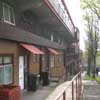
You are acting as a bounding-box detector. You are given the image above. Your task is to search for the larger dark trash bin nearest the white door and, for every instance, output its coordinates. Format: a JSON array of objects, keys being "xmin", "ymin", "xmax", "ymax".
[{"xmin": 28, "ymin": 74, "xmax": 40, "ymax": 91}]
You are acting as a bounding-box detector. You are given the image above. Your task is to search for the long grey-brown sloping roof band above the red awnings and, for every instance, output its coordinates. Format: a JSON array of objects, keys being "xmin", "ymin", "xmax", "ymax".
[{"xmin": 0, "ymin": 22, "xmax": 64, "ymax": 49}]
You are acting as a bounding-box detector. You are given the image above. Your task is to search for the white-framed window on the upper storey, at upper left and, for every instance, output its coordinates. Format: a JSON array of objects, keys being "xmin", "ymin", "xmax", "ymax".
[{"xmin": 3, "ymin": 3, "xmax": 15, "ymax": 25}]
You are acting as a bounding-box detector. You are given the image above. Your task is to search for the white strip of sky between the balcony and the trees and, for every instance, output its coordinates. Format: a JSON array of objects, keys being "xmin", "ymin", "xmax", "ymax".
[{"xmin": 65, "ymin": 0, "xmax": 86, "ymax": 51}]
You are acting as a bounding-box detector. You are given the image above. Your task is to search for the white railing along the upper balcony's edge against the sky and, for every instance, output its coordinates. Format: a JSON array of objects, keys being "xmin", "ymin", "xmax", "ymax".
[{"xmin": 44, "ymin": 0, "xmax": 75, "ymax": 35}]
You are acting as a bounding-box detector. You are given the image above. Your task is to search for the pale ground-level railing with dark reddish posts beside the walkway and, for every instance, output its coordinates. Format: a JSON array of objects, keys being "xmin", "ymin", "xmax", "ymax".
[{"xmin": 46, "ymin": 72, "xmax": 82, "ymax": 100}]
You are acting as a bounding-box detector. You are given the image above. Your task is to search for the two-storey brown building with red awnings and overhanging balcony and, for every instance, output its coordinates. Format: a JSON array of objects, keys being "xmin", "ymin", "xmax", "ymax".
[{"xmin": 0, "ymin": 0, "xmax": 80, "ymax": 89}]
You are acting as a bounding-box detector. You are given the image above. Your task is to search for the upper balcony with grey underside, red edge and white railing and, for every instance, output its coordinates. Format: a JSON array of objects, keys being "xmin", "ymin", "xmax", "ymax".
[{"xmin": 4, "ymin": 0, "xmax": 75, "ymax": 42}]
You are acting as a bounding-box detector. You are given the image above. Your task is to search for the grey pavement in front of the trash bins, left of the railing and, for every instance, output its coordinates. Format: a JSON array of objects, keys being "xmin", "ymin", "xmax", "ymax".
[{"xmin": 21, "ymin": 82, "xmax": 58, "ymax": 100}]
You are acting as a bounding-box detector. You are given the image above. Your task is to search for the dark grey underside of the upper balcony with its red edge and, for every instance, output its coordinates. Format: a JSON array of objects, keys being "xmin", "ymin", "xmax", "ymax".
[{"xmin": 5, "ymin": 0, "xmax": 74, "ymax": 40}]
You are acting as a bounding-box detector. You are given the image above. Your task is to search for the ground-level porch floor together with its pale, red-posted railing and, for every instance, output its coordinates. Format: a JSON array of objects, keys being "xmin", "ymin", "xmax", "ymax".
[{"xmin": 22, "ymin": 73, "xmax": 83, "ymax": 100}]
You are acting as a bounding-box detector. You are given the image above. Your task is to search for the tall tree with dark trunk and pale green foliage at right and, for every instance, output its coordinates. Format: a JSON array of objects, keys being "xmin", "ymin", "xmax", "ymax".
[{"xmin": 81, "ymin": 0, "xmax": 100, "ymax": 78}]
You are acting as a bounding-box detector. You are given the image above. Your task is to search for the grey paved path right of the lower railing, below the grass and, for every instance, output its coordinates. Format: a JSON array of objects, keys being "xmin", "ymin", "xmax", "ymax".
[{"xmin": 83, "ymin": 81, "xmax": 100, "ymax": 100}]
